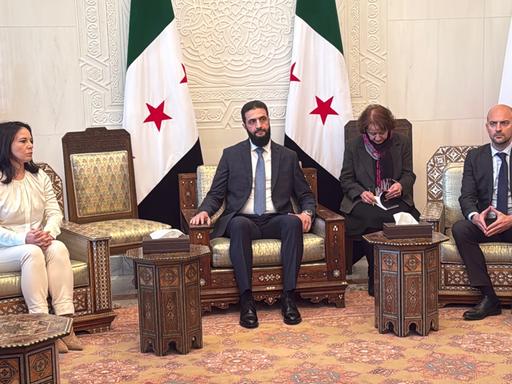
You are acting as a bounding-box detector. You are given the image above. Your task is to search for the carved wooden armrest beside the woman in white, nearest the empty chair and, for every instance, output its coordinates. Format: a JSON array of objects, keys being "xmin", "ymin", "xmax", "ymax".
[{"xmin": 57, "ymin": 221, "xmax": 112, "ymax": 313}]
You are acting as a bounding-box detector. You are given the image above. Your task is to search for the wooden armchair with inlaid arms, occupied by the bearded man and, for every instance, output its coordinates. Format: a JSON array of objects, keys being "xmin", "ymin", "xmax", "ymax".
[{"xmin": 179, "ymin": 166, "xmax": 347, "ymax": 311}]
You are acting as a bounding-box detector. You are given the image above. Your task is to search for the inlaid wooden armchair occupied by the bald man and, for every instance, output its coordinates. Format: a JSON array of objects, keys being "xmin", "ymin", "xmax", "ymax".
[{"xmin": 421, "ymin": 146, "xmax": 512, "ymax": 304}]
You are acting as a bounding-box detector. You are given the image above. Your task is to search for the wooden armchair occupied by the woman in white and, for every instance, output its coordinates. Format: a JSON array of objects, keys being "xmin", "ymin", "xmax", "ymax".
[{"xmin": 0, "ymin": 163, "xmax": 115, "ymax": 332}]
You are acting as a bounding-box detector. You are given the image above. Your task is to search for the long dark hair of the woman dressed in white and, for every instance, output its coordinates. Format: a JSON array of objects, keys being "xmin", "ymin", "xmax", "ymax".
[{"xmin": 0, "ymin": 121, "xmax": 39, "ymax": 184}]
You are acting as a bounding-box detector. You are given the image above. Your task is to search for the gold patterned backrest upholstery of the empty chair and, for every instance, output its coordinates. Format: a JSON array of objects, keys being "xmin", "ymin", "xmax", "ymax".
[{"xmin": 70, "ymin": 151, "xmax": 132, "ymax": 217}]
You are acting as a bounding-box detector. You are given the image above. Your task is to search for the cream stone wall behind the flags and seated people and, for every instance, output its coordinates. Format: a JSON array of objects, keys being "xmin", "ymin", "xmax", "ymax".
[{"xmin": 0, "ymin": 0, "xmax": 512, "ymax": 209}]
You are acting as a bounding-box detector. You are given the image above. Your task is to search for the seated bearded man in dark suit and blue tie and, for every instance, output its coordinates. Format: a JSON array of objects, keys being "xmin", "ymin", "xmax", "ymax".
[{"xmin": 190, "ymin": 100, "xmax": 316, "ymax": 328}]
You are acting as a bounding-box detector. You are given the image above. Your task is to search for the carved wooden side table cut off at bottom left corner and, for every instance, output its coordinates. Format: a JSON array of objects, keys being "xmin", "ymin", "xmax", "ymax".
[{"xmin": 0, "ymin": 313, "xmax": 73, "ymax": 384}]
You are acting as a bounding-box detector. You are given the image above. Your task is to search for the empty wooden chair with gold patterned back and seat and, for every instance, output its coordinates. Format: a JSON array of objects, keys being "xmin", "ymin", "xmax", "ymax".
[{"xmin": 62, "ymin": 128, "xmax": 170, "ymax": 255}]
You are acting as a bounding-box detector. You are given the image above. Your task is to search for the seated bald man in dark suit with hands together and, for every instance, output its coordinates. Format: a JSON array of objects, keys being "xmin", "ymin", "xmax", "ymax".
[{"xmin": 452, "ymin": 104, "xmax": 512, "ymax": 320}]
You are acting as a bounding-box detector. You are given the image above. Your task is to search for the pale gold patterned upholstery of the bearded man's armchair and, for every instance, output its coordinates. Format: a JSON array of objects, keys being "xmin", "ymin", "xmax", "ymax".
[{"xmin": 197, "ymin": 165, "xmax": 325, "ymax": 268}]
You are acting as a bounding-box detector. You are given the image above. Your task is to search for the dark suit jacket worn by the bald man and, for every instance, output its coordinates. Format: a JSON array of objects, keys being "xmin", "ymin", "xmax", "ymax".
[{"xmin": 459, "ymin": 144, "xmax": 512, "ymax": 218}]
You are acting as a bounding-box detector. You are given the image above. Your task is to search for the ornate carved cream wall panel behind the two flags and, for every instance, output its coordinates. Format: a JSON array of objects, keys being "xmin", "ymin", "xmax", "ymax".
[{"xmin": 76, "ymin": 0, "xmax": 386, "ymax": 136}]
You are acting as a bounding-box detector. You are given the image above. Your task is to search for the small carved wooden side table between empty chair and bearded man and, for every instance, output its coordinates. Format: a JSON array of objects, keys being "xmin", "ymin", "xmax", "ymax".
[{"xmin": 126, "ymin": 245, "xmax": 210, "ymax": 356}]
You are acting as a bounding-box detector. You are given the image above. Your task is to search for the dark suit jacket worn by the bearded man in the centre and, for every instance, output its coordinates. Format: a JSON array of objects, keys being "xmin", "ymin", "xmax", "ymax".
[{"xmin": 198, "ymin": 139, "xmax": 316, "ymax": 238}]
